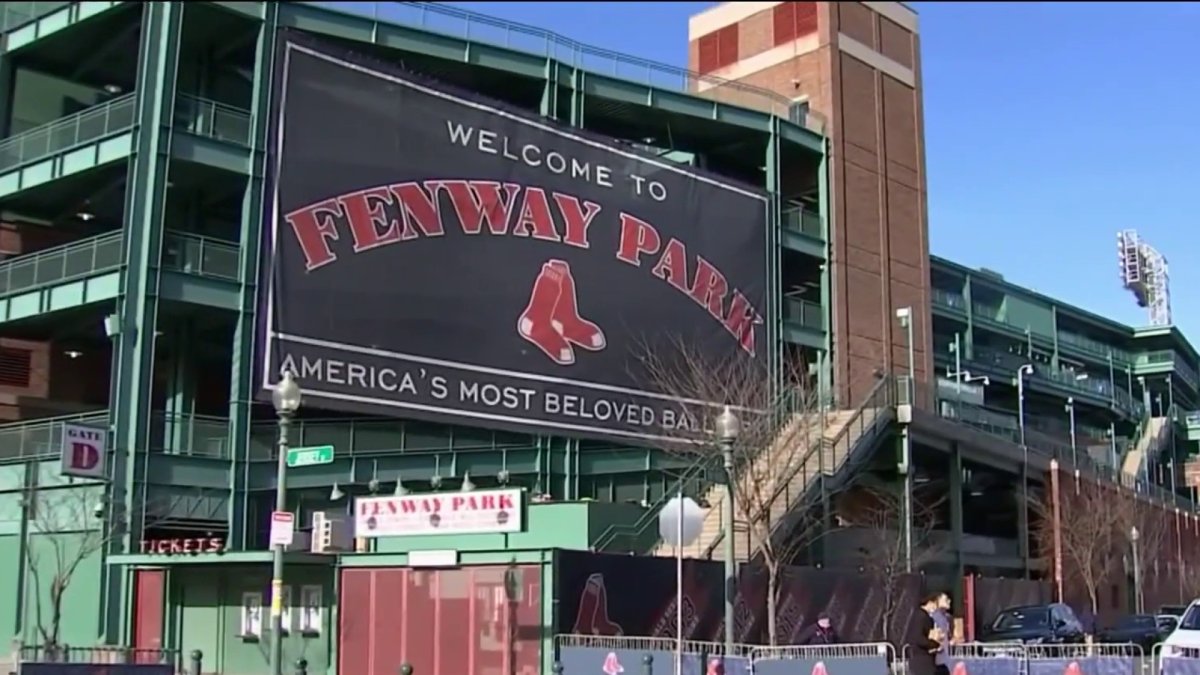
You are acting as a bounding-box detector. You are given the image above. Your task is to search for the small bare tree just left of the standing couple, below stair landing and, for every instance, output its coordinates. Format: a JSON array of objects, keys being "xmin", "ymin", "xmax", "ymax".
[{"xmin": 838, "ymin": 482, "xmax": 947, "ymax": 640}]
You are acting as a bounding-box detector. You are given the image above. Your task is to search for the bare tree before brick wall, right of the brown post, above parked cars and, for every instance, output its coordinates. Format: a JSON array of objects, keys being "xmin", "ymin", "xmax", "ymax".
[{"xmin": 1030, "ymin": 477, "xmax": 1138, "ymax": 614}]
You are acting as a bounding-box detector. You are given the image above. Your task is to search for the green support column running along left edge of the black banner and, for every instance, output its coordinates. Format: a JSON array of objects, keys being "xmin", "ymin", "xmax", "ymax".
[{"xmin": 229, "ymin": 2, "xmax": 280, "ymax": 550}]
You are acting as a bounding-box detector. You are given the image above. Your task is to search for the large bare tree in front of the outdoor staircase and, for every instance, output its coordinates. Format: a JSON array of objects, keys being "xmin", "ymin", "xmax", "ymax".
[{"xmin": 640, "ymin": 340, "xmax": 835, "ymax": 644}]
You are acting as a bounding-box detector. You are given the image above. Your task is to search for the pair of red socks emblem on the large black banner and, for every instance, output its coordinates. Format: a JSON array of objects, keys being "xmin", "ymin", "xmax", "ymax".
[{"xmin": 517, "ymin": 261, "xmax": 607, "ymax": 365}]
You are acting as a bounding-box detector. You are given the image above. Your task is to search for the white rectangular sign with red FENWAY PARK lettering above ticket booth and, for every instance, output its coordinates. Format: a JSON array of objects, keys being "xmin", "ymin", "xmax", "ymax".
[{"xmin": 354, "ymin": 490, "xmax": 524, "ymax": 537}]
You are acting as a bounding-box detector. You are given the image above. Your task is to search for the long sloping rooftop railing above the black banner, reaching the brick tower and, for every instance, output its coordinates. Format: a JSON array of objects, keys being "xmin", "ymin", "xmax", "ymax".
[{"xmin": 311, "ymin": 2, "xmax": 826, "ymax": 132}]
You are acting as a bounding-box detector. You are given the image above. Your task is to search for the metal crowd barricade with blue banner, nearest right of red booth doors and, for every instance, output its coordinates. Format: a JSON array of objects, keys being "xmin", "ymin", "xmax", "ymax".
[{"xmin": 554, "ymin": 634, "xmax": 754, "ymax": 675}]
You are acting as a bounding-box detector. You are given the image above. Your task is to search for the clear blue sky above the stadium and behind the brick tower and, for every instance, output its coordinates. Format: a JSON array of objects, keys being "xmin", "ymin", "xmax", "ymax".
[{"xmin": 436, "ymin": 2, "xmax": 1200, "ymax": 336}]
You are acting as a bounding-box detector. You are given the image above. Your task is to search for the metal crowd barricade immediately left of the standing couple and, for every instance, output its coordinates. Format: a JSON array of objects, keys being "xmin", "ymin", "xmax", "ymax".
[{"xmin": 748, "ymin": 643, "xmax": 895, "ymax": 675}]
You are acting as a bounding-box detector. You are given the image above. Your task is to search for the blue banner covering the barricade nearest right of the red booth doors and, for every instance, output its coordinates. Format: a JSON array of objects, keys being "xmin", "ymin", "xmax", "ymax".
[{"xmin": 558, "ymin": 647, "xmax": 744, "ymax": 675}]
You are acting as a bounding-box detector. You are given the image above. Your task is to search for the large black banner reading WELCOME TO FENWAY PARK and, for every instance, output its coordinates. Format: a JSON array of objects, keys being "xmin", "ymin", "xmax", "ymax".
[{"xmin": 258, "ymin": 32, "xmax": 767, "ymax": 438}]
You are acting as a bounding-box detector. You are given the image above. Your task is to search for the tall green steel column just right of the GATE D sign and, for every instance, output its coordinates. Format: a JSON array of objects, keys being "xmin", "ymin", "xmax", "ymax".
[{"xmin": 101, "ymin": 2, "xmax": 184, "ymax": 640}]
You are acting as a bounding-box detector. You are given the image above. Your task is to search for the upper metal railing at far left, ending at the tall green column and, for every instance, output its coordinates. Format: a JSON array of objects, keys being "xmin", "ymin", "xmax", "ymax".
[{"xmin": 0, "ymin": 94, "xmax": 136, "ymax": 172}]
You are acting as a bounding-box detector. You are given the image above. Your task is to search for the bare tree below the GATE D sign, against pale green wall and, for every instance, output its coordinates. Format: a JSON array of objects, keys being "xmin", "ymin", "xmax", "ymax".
[{"xmin": 24, "ymin": 475, "xmax": 162, "ymax": 658}]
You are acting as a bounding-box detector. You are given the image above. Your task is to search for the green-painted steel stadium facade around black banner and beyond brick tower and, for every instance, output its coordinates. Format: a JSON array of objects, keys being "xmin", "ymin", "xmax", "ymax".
[{"xmin": 0, "ymin": 2, "xmax": 1200, "ymax": 673}]
